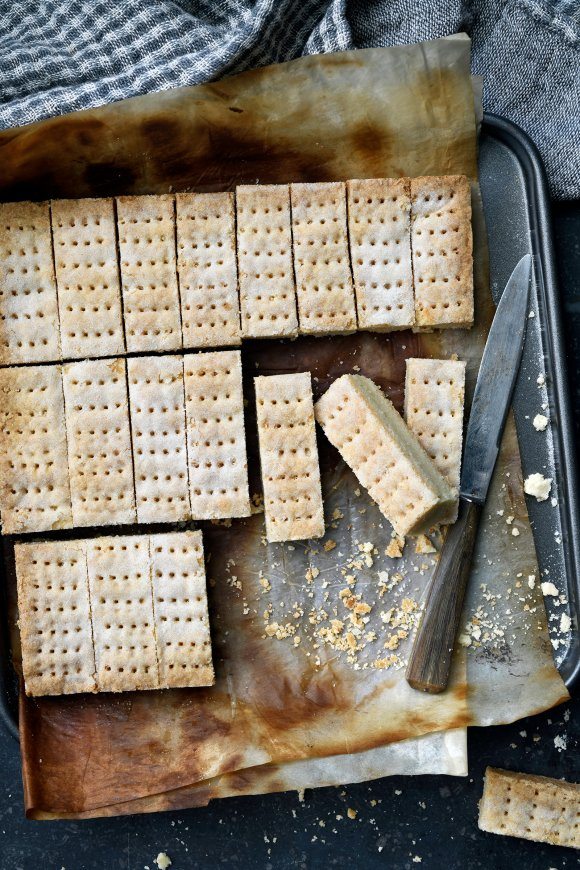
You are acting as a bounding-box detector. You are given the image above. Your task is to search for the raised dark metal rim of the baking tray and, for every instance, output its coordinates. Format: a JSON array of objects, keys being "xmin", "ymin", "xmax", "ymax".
[{"xmin": 0, "ymin": 112, "xmax": 580, "ymax": 741}]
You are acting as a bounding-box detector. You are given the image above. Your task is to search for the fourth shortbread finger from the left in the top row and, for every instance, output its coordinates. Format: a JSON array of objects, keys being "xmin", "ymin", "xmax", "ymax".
[{"xmin": 175, "ymin": 193, "xmax": 241, "ymax": 347}]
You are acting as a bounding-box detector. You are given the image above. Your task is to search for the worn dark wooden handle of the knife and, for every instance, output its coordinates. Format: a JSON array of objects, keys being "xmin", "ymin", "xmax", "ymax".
[{"xmin": 405, "ymin": 500, "xmax": 481, "ymax": 694}]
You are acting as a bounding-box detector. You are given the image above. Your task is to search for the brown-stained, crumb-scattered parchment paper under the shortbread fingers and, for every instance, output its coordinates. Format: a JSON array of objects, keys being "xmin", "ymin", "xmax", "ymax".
[{"xmin": 0, "ymin": 38, "xmax": 566, "ymax": 817}]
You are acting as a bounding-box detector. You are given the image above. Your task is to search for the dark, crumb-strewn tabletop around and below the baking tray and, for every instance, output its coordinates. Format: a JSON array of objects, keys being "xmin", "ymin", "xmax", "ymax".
[{"xmin": 0, "ymin": 202, "xmax": 580, "ymax": 870}]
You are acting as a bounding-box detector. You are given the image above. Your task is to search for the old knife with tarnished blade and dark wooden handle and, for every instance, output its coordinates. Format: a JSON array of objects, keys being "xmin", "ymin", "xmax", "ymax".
[{"xmin": 405, "ymin": 254, "xmax": 532, "ymax": 694}]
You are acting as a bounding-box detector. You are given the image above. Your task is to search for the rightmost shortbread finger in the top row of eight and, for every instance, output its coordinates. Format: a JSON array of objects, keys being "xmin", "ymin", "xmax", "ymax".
[{"xmin": 411, "ymin": 175, "xmax": 473, "ymax": 329}]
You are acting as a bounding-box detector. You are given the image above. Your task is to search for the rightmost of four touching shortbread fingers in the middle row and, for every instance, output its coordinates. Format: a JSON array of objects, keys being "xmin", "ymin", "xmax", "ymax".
[{"xmin": 183, "ymin": 350, "xmax": 250, "ymax": 520}]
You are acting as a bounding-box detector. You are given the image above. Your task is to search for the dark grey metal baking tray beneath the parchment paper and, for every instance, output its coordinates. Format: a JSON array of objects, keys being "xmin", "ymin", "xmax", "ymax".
[{"xmin": 0, "ymin": 115, "xmax": 580, "ymax": 739}]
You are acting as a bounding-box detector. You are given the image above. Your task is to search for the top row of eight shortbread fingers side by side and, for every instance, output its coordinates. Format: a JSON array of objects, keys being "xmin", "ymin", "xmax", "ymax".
[{"xmin": 0, "ymin": 176, "xmax": 473, "ymax": 365}]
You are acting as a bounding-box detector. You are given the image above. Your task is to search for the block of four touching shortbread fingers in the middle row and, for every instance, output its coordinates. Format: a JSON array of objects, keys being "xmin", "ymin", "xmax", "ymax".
[{"xmin": 0, "ymin": 350, "xmax": 250, "ymax": 534}]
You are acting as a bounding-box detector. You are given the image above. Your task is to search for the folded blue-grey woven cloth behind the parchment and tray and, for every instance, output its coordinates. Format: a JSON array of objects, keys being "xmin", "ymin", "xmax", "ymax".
[{"xmin": 0, "ymin": 0, "xmax": 580, "ymax": 199}]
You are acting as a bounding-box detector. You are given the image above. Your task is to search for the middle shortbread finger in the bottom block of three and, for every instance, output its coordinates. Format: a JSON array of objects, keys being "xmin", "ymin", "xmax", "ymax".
[{"xmin": 87, "ymin": 535, "xmax": 159, "ymax": 692}]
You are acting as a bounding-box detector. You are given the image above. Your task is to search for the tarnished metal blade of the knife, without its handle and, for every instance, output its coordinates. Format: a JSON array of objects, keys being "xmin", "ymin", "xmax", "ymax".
[{"xmin": 459, "ymin": 254, "xmax": 532, "ymax": 505}]
